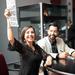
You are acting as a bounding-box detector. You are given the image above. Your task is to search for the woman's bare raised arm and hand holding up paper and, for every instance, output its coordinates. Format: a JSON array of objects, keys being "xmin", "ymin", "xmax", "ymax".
[{"xmin": 4, "ymin": 9, "xmax": 14, "ymax": 45}]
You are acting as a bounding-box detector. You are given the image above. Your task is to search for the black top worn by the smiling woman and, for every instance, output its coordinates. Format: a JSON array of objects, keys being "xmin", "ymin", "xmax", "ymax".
[{"xmin": 8, "ymin": 39, "xmax": 48, "ymax": 75}]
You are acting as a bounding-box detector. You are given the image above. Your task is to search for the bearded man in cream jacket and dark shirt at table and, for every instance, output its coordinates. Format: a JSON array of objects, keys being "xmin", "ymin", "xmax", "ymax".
[{"xmin": 37, "ymin": 22, "xmax": 75, "ymax": 59}]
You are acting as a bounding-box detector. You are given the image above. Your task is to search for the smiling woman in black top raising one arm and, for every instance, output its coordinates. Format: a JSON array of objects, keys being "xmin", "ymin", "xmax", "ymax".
[{"xmin": 4, "ymin": 9, "xmax": 52, "ymax": 75}]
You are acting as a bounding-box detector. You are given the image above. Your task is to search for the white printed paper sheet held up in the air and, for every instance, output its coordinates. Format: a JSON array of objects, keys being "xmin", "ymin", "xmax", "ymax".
[{"xmin": 6, "ymin": 0, "xmax": 19, "ymax": 27}]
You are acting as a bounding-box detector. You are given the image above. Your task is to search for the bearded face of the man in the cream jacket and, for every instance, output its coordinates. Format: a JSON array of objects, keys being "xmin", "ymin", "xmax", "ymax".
[{"xmin": 48, "ymin": 26, "xmax": 59, "ymax": 40}]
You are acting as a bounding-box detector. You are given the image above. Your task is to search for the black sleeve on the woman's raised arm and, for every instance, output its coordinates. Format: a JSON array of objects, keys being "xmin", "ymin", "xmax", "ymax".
[{"xmin": 8, "ymin": 38, "xmax": 23, "ymax": 53}]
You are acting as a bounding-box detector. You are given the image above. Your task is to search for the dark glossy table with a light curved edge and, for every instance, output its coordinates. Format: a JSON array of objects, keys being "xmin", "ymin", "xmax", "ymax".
[{"xmin": 47, "ymin": 56, "xmax": 75, "ymax": 75}]
